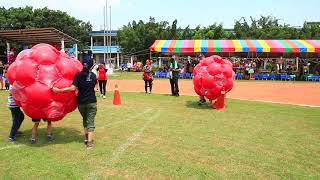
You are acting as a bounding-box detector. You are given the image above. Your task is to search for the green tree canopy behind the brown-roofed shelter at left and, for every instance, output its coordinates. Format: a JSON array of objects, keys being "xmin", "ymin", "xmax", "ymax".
[{"xmin": 0, "ymin": 6, "xmax": 92, "ymax": 49}]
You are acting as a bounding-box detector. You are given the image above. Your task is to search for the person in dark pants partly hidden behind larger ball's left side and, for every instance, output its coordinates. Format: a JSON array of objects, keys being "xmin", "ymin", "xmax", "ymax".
[{"xmin": 7, "ymin": 86, "xmax": 24, "ymax": 142}]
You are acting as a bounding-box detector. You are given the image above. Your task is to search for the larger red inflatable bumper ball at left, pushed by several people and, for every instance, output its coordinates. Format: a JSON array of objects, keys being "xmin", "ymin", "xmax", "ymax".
[{"xmin": 8, "ymin": 44, "xmax": 82, "ymax": 121}]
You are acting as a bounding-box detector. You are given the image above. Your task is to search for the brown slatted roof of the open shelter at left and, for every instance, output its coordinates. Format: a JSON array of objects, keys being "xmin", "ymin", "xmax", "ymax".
[{"xmin": 0, "ymin": 28, "xmax": 78, "ymax": 44}]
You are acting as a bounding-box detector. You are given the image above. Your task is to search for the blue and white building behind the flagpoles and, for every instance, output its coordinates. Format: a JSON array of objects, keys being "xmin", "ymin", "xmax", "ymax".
[{"xmin": 88, "ymin": 30, "xmax": 121, "ymax": 67}]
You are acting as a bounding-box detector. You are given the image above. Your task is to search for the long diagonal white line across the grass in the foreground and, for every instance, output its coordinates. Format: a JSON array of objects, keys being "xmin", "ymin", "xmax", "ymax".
[{"xmin": 87, "ymin": 111, "xmax": 160, "ymax": 180}]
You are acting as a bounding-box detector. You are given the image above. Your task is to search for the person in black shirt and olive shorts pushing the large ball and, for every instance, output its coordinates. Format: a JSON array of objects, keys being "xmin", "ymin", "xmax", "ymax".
[{"xmin": 52, "ymin": 64, "xmax": 97, "ymax": 149}]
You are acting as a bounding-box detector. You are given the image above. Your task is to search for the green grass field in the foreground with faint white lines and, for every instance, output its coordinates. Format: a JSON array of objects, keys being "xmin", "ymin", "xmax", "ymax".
[{"xmin": 0, "ymin": 91, "xmax": 320, "ymax": 179}]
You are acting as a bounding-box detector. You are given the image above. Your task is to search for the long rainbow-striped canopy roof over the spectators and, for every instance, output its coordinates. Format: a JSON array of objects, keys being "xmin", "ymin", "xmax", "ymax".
[{"xmin": 150, "ymin": 40, "xmax": 320, "ymax": 53}]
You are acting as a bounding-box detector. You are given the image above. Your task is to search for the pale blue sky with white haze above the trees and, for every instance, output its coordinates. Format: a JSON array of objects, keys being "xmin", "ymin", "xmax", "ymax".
[{"xmin": 0, "ymin": 0, "xmax": 320, "ymax": 30}]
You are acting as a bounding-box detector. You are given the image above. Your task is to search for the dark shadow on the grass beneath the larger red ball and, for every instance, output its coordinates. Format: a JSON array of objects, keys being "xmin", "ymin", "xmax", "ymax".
[{"xmin": 16, "ymin": 127, "xmax": 83, "ymax": 147}]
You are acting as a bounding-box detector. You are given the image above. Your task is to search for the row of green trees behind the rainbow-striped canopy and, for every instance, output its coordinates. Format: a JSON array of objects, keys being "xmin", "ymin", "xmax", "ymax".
[{"xmin": 118, "ymin": 16, "xmax": 320, "ymax": 57}]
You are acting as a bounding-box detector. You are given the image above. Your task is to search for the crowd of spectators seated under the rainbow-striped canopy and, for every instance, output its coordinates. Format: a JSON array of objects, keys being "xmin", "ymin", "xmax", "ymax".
[{"xmin": 154, "ymin": 55, "xmax": 320, "ymax": 80}]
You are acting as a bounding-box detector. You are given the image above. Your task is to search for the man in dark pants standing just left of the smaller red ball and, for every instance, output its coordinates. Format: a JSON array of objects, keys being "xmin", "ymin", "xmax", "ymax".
[{"xmin": 169, "ymin": 58, "xmax": 181, "ymax": 97}]
